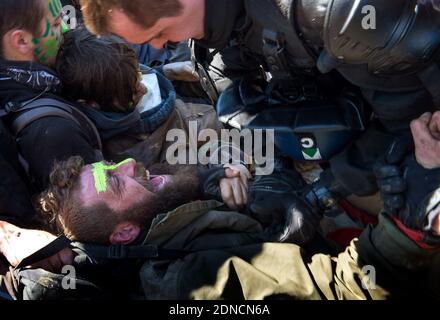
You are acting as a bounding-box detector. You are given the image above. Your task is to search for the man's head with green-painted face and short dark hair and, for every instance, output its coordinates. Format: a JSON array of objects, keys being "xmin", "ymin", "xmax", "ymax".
[{"xmin": 0, "ymin": 0, "xmax": 63, "ymax": 65}]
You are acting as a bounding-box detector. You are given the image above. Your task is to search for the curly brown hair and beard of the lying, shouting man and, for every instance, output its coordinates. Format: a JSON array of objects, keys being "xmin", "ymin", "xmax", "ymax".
[{"xmin": 38, "ymin": 157, "xmax": 158, "ymax": 244}]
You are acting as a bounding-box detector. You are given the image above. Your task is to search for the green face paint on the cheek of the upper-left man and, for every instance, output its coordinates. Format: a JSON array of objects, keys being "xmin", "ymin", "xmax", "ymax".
[{"xmin": 32, "ymin": 0, "xmax": 68, "ymax": 63}]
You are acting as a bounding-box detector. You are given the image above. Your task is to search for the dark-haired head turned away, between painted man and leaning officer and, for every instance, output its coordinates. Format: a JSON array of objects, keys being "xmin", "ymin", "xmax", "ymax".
[{"xmin": 55, "ymin": 28, "xmax": 145, "ymax": 112}]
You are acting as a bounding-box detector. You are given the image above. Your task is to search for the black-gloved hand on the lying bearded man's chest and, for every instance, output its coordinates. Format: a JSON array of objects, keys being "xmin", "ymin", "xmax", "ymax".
[{"xmin": 248, "ymin": 169, "xmax": 321, "ymax": 245}]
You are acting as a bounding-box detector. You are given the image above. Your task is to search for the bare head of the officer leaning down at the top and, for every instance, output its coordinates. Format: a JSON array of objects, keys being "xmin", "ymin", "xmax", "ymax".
[{"xmin": 80, "ymin": 0, "xmax": 205, "ymax": 49}]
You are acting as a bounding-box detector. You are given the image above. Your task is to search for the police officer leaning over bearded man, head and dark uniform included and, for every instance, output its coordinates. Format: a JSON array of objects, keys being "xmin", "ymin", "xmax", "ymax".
[{"xmin": 82, "ymin": 0, "xmax": 440, "ymax": 242}]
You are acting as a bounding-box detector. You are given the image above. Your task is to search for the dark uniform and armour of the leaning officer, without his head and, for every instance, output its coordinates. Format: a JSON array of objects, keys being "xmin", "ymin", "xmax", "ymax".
[{"xmin": 194, "ymin": 0, "xmax": 440, "ymax": 240}]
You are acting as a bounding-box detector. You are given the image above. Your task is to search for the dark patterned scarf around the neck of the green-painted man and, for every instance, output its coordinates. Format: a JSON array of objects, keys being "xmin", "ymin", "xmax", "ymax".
[{"xmin": 0, "ymin": 60, "xmax": 62, "ymax": 94}]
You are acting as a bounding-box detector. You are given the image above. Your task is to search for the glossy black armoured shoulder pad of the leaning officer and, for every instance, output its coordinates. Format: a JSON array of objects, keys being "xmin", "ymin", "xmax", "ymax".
[{"xmin": 324, "ymin": 0, "xmax": 440, "ymax": 74}]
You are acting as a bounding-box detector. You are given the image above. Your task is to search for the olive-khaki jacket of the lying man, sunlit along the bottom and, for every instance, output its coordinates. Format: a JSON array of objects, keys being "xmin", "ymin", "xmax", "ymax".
[{"xmin": 140, "ymin": 201, "xmax": 438, "ymax": 300}]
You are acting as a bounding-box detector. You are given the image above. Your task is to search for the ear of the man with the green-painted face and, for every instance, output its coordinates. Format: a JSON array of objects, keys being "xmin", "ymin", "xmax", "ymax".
[{"xmin": 3, "ymin": 29, "xmax": 35, "ymax": 61}]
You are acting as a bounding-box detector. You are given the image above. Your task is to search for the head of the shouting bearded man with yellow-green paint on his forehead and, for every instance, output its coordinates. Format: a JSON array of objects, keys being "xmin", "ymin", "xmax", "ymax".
[{"xmin": 39, "ymin": 157, "xmax": 199, "ymax": 244}]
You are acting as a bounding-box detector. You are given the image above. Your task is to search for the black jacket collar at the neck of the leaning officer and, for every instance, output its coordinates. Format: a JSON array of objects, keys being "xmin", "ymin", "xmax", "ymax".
[{"xmin": 197, "ymin": 0, "xmax": 246, "ymax": 49}]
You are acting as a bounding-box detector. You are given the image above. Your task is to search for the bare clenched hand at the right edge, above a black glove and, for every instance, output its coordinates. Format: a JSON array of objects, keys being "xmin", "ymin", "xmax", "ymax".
[{"xmin": 411, "ymin": 112, "xmax": 440, "ymax": 169}]
